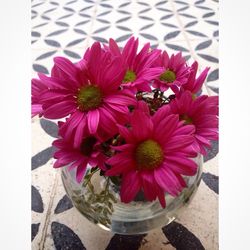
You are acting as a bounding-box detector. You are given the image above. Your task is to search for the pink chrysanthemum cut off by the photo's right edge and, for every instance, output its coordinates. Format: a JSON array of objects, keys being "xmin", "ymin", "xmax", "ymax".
[{"xmin": 169, "ymin": 91, "xmax": 218, "ymax": 155}]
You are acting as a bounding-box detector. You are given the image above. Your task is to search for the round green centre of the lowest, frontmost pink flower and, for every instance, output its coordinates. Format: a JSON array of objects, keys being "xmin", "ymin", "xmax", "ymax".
[{"xmin": 135, "ymin": 140, "xmax": 163, "ymax": 170}]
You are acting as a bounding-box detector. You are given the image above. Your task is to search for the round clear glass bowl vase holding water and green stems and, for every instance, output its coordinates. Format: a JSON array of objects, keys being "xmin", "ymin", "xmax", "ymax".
[{"xmin": 61, "ymin": 155, "xmax": 203, "ymax": 234}]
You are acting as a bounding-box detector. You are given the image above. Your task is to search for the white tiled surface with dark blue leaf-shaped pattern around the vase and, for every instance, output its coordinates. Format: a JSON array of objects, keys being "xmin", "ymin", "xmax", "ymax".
[{"xmin": 31, "ymin": 0, "xmax": 219, "ymax": 250}]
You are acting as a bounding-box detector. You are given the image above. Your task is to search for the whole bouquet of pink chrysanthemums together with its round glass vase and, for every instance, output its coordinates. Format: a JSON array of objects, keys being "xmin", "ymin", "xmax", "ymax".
[{"xmin": 32, "ymin": 37, "xmax": 218, "ymax": 234}]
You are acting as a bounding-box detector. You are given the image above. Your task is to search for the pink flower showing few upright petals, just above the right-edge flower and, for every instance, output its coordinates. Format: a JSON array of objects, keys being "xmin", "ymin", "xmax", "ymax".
[{"xmin": 181, "ymin": 62, "xmax": 209, "ymax": 94}]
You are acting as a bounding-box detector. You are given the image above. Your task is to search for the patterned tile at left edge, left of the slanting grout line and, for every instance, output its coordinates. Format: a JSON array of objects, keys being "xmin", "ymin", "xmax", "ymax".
[{"xmin": 31, "ymin": 118, "xmax": 56, "ymax": 246}]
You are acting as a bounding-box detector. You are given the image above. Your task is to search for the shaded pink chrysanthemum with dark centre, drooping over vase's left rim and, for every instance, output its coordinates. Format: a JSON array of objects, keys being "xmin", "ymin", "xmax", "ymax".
[{"xmin": 52, "ymin": 123, "xmax": 107, "ymax": 182}]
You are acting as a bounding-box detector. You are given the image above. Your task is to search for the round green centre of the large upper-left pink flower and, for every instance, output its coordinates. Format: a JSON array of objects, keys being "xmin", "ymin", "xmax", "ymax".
[{"xmin": 77, "ymin": 85, "xmax": 102, "ymax": 111}]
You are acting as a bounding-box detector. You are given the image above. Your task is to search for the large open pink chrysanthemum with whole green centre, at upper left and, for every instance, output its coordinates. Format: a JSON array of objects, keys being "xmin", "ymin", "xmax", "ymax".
[{"xmin": 32, "ymin": 42, "xmax": 136, "ymax": 146}]
